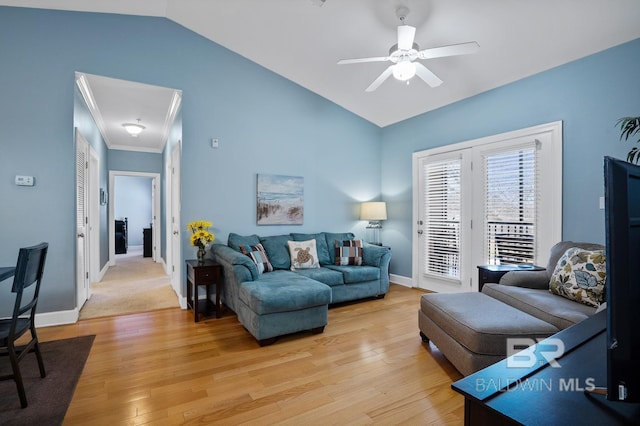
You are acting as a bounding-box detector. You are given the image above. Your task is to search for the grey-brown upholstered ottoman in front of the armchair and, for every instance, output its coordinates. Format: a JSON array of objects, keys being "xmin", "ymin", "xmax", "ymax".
[{"xmin": 418, "ymin": 293, "xmax": 559, "ymax": 376}]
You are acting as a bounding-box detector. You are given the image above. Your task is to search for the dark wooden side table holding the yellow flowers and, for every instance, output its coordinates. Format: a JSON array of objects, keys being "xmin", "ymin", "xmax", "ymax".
[{"xmin": 186, "ymin": 259, "xmax": 222, "ymax": 322}]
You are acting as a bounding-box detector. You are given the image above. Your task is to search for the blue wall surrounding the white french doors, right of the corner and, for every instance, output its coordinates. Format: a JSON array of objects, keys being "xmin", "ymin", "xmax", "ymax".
[{"xmin": 382, "ymin": 39, "xmax": 640, "ymax": 276}]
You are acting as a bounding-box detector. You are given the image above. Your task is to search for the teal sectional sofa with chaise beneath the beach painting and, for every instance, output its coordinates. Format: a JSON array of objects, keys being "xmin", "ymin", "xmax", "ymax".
[{"xmin": 207, "ymin": 232, "xmax": 391, "ymax": 345}]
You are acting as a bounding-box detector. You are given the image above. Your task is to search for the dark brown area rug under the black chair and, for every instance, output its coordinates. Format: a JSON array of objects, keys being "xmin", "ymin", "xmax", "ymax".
[{"xmin": 0, "ymin": 336, "xmax": 95, "ymax": 426}]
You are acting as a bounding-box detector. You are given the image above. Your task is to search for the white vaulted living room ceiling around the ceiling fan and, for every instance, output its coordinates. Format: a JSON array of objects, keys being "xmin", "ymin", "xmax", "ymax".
[{"xmin": 5, "ymin": 0, "xmax": 640, "ymax": 147}]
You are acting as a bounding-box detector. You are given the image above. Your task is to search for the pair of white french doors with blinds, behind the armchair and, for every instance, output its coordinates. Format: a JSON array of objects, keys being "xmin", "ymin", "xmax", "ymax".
[{"xmin": 413, "ymin": 122, "xmax": 562, "ymax": 292}]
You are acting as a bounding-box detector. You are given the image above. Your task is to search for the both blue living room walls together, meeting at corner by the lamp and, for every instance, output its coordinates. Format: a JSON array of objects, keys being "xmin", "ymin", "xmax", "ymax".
[{"xmin": 0, "ymin": 7, "xmax": 640, "ymax": 313}]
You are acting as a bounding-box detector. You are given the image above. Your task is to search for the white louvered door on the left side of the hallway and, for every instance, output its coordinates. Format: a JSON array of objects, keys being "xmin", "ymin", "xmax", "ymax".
[{"xmin": 75, "ymin": 128, "xmax": 90, "ymax": 310}]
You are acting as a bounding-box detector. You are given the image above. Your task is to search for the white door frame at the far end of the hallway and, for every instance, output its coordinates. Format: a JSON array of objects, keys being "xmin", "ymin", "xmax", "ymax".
[{"xmin": 109, "ymin": 170, "xmax": 162, "ymax": 266}]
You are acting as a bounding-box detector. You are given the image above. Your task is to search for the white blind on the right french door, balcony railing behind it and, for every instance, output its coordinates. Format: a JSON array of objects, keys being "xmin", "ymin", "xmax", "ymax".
[{"xmin": 482, "ymin": 141, "xmax": 538, "ymax": 265}]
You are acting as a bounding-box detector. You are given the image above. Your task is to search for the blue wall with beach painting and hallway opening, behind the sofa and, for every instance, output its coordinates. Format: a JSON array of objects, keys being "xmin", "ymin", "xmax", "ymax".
[{"xmin": 0, "ymin": 7, "xmax": 381, "ymax": 313}]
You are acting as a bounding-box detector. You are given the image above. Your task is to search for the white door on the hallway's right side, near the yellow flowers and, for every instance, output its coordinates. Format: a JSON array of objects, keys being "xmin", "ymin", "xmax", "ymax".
[{"xmin": 170, "ymin": 142, "xmax": 182, "ymax": 296}]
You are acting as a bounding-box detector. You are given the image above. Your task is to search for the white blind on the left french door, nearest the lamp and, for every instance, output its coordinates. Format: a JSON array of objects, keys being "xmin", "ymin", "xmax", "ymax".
[{"xmin": 423, "ymin": 159, "xmax": 461, "ymax": 280}]
